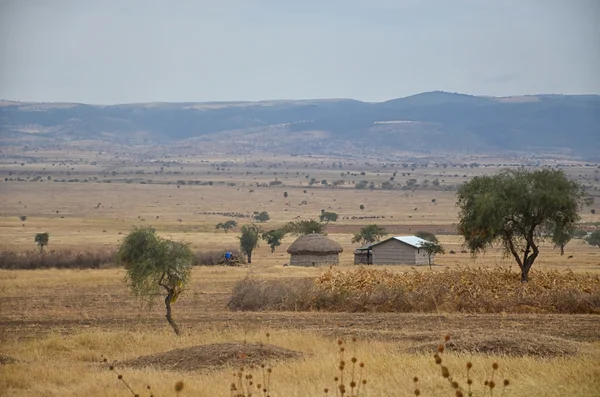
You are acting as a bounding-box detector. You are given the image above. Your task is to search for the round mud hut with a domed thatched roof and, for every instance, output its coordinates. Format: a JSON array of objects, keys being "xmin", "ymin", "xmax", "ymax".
[{"xmin": 288, "ymin": 234, "xmax": 343, "ymax": 266}]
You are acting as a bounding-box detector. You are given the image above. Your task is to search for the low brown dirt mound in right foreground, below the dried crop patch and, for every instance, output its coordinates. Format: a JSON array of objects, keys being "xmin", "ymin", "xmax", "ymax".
[{"xmin": 409, "ymin": 333, "xmax": 581, "ymax": 358}]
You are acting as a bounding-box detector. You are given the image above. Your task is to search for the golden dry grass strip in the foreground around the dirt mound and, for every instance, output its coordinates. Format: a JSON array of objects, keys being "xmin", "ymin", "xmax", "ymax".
[{"xmin": 0, "ymin": 325, "xmax": 600, "ymax": 396}]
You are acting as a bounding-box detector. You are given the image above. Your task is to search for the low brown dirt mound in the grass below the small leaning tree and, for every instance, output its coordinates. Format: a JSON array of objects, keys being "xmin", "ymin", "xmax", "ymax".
[{"xmin": 120, "ymin": 343, "xmax": 303, "ymax": 371}]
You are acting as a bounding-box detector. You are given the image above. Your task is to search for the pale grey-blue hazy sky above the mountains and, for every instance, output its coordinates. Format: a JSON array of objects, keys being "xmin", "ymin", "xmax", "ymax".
[{"xmin": 0, "ymin": 0, "xmax": 600, "ymax": 104}]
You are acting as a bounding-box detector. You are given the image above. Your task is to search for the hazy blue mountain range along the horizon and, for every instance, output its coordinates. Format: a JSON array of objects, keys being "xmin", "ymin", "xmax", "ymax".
[{"xmin": 0, "ymin": 92, "xmax": 600, "ymax": 158}]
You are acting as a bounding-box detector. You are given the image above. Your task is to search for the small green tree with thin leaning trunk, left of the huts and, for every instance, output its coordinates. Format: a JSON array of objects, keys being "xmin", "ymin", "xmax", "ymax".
[{"xmin": 117, "ymin": 228, "xmax": 194, "ymax": 335}]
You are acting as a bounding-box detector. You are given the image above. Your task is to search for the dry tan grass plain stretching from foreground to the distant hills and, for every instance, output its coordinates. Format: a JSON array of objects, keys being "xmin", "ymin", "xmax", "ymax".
[{"xmin": 0, "ymin": 148, "xmax": 600, "ymax": 396}]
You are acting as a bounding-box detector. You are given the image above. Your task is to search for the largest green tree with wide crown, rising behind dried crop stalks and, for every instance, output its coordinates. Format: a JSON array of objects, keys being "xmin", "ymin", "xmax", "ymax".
[{"xmin": 457, "ymin": 169, "xmax": 583, "ymax": 282}]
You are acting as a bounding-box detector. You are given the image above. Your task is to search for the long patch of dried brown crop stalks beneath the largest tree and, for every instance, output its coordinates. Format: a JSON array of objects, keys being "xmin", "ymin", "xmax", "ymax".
[{"xmin": 228, "ymin": 267, "xmax": 600, "ymax": 314}]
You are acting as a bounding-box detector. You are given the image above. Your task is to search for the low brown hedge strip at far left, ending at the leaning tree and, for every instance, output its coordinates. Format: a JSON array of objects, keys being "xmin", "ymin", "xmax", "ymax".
[{"xmin": 0, "ymin": 248, "xmax": 118, "ymax": 270}]
